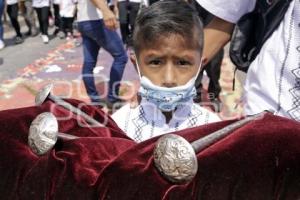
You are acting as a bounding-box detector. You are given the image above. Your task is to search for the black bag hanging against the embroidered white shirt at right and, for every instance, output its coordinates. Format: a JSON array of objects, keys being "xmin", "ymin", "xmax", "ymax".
[{"xmin": 229, "ymin": 0, "xmax": 292, "ymax": 72}]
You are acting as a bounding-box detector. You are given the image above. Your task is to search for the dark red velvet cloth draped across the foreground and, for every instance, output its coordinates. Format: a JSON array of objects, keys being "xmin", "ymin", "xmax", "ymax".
[{"xmin": 0, "ymin": 100, "xmax": 300, "ymax": 200}]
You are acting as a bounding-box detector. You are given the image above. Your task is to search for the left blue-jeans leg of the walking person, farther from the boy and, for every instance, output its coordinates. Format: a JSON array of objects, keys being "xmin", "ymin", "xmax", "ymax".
[{"xmin": 78, "ymin": 22, "xmax": 100, "ymax": 102}]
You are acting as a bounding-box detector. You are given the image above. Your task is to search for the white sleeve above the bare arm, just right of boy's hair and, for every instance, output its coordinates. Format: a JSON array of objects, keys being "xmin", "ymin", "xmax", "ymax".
[{"xmin": 196, "ymin": 0, "xmax": 256, "ymax": 23}]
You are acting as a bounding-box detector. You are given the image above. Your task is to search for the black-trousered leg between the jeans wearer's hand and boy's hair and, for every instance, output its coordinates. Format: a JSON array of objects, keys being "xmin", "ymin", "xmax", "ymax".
[{"xmin": 118, "ymin": 1, "xmax": 129, "ymax": 44}]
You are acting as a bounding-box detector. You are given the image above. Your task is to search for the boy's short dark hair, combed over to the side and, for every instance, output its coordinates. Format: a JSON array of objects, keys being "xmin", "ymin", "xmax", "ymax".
[{"xmin": 133, "ymin": 0, "xmax": 203, "ymax": 54}]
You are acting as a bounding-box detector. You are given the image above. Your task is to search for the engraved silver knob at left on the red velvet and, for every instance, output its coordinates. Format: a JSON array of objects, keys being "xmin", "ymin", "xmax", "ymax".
[{"xmin": 28, "ymin": 112, "xmax": 58, "ymax": 155}]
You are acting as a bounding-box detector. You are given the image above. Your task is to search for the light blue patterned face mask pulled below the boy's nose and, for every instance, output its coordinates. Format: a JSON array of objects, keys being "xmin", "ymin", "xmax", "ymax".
[{"xmin": 137, "ymin": 59, "xmax": 201, "ymax": 112}]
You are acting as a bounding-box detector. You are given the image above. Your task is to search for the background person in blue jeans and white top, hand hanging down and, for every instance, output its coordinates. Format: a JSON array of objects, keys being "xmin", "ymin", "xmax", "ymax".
[{"xmin": 77, "ymin": 0, "xmax": 128, "ymax": 108}]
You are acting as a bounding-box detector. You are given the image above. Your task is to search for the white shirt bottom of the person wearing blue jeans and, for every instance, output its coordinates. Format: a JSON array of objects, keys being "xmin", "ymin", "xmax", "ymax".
[{"xmin": 77, "ymin": 0, "xmax": 103, "ymax": 22}]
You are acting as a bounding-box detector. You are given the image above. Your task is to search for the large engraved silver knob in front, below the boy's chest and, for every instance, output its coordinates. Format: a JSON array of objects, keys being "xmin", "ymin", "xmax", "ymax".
[{"xmin": 154, "ymin": 134, "xmax": 198, "ymax": 183}]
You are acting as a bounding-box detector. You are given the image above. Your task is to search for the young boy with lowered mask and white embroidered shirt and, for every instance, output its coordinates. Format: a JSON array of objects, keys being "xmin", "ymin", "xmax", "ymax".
[{"xmin": 112, "ymin": 1, "xmax": 220, "ymax": 142}]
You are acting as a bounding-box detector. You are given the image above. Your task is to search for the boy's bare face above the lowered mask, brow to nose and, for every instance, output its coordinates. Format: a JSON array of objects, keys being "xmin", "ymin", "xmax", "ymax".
[{"xmin": 138, "ymin": 34, "xmax": 201, "ymax": 87}]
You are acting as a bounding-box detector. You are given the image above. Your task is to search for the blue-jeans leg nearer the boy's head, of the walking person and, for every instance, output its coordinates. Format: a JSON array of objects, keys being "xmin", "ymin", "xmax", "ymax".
[{"xmin": 97, "ymin": 20, "xmax": 128, "ymax": 103}]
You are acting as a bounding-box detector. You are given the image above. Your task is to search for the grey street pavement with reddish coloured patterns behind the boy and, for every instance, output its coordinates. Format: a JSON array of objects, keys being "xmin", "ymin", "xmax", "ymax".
[{"xmin": 0, "ymin": 21, "xmax": 243, "ymax": 119}]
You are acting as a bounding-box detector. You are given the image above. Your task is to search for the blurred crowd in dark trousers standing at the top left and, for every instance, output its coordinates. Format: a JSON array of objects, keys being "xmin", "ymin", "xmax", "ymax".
[{"xmin": 0, "ymin": 0, "xmax": 77, "ymax": 49}]
